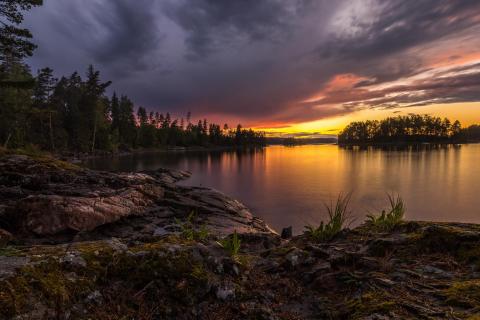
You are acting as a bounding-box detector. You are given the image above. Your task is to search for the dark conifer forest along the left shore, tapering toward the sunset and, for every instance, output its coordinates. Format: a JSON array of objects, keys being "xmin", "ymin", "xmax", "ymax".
[{"xmin": 0, "ymin": 0, "xmax": 265, "ymax": 152}]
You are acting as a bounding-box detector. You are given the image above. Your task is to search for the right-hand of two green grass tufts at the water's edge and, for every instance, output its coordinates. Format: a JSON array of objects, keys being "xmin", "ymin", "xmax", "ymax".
[{"xmin": 366, "ymin": 194, "xmax": 406, "ymax": 232}]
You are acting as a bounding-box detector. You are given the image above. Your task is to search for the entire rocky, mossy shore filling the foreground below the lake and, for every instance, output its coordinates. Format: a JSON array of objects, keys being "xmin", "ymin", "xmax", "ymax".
[{"xmin": 0, "ymin": 155, "xmax": 480, "ymax": 319}]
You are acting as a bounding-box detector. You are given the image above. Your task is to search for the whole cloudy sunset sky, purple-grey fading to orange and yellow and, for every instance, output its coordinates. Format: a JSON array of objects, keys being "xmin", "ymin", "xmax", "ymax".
[{"xmin": 24, "ymin": 0, "xmax": 480, "ymax": 137}]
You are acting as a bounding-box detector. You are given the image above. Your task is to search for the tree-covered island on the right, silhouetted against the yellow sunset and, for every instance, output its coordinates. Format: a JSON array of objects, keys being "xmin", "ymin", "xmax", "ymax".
[{"xmin": 338, "ymin": 114, "xmax": 480, "ymax": 144}]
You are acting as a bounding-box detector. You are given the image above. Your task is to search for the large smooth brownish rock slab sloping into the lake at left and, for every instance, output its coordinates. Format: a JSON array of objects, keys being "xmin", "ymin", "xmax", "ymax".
[{"xmin": 0, "ymin": 156, "xmax": 280, "ymax": 244}]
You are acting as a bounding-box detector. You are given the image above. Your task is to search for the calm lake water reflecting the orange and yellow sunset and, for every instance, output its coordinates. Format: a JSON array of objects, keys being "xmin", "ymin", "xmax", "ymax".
[{"xmin": 87, "ymin": 144, "xmax": 480, "ymax": 233}]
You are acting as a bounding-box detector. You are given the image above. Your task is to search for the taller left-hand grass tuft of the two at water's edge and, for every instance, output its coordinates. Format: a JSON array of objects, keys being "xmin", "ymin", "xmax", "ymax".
[{"xmin": 305, "ymin": 193, "xmax": 351, "ymax": 242}]
